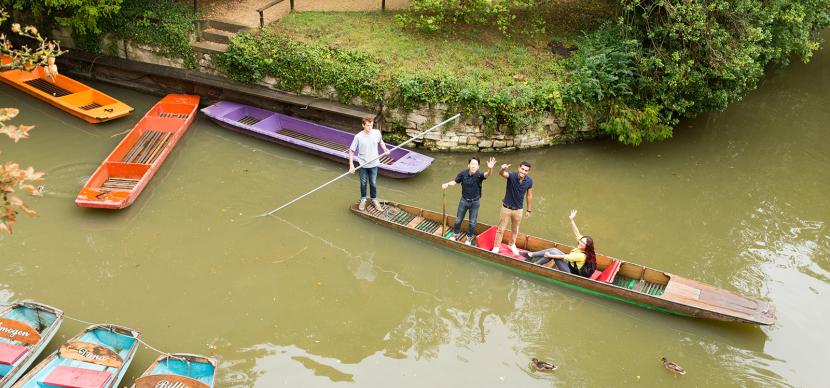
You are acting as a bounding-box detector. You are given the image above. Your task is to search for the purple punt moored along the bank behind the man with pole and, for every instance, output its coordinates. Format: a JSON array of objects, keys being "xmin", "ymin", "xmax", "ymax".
[{"xmin": 202, "ymin": 101, "xmax": 433, "ymax": 178}]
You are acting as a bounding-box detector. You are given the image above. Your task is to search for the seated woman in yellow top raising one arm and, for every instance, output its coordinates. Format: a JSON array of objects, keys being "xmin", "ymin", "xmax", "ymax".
[{"xmin": 522, "ymin": 210, "xmax": 597, "ymax": 278}]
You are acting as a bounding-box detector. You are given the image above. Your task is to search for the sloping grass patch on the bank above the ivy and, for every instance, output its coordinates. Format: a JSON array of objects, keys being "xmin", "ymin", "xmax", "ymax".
[{"xmin": 266, "ymin": 0, "xmax": 609, "ymax": 87}]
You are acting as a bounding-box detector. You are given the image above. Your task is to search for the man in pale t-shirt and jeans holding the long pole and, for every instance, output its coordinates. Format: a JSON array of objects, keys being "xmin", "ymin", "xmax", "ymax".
[{"xmin": 349, "ymin": 115, "xmax": 390, "ymax": 210}]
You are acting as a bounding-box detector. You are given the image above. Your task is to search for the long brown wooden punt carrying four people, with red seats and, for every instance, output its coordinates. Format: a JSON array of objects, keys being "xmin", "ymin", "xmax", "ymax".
[{"xmin": 351, "ymin": 202, "xmax": 775, "ymax": 325}]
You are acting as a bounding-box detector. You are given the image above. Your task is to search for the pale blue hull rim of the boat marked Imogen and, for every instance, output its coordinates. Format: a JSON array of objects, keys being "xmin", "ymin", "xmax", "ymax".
[{"xmin": 0, "ymin": 302, "xmax": 63, "ymax": 388}]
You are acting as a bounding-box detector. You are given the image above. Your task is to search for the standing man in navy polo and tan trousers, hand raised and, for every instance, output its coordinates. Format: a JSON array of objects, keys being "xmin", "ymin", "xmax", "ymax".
[{"xmin": 492, "ymin": 161, "xmax": 533, "ymax": 255}]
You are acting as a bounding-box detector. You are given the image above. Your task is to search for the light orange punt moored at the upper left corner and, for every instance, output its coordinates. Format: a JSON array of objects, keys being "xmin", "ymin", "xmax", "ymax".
[{"xmin": 0, "ymin": 55, "xmax": 133, "ymax": 124}]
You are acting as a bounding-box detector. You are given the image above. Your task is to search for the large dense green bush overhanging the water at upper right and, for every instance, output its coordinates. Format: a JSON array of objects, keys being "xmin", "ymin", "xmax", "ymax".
[{"xmin": 568, "ymin": 0, "xmax": 830, "ymax": 145}]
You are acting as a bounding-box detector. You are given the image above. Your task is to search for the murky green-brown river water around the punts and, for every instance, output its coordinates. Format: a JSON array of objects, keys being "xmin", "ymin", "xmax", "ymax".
[{"xmin": 0, "ymin": 34, "xmax": 830, "ymax": 387}]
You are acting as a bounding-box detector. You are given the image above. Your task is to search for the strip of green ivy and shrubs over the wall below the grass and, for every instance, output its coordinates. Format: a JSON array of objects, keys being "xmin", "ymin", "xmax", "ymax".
[{"xmin": 216, "ymin": 34, "xmax": 564, "ymax": 136}]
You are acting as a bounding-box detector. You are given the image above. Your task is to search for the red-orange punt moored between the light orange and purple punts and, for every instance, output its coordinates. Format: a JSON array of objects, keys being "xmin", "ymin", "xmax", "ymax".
[{"xmin": 75, "ymin": 94, "xmax": 199, "ymax": 209}]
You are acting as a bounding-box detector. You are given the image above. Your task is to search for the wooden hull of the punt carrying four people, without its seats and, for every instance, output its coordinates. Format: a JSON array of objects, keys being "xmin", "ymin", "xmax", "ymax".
[{"xmin": 350, "ymin": 202, "xmax": 775, "ymax": 325}]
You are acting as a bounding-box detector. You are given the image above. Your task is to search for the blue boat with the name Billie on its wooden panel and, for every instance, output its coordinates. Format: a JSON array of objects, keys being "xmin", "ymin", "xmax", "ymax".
[{"xmin": 133, "ymin": 353, "xmax": 216, "ymax": 388}]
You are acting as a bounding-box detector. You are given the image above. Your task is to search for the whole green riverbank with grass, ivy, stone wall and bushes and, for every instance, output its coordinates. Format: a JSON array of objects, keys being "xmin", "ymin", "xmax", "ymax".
[{"xmin": 8, "ymin": 0, "xmax": 830, "ymax": 152}]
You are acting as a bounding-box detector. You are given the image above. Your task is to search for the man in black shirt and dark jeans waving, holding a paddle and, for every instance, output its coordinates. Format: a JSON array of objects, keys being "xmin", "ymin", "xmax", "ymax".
[{"xmin": 441, "ymin": 156, "xmax": 496, "ymax": 245}]
